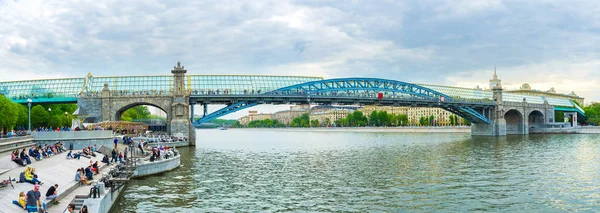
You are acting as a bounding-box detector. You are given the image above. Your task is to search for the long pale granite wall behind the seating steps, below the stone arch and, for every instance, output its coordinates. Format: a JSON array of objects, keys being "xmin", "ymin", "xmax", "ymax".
[{"xmin": 31, "ymin": 131, "xmax": 114, "ymax": 149}]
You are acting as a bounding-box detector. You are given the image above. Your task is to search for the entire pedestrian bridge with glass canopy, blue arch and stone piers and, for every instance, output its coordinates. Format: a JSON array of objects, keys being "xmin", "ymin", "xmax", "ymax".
[{"xmin": 0, "ymin": 63, "xmax": 585, "ymax": 141}]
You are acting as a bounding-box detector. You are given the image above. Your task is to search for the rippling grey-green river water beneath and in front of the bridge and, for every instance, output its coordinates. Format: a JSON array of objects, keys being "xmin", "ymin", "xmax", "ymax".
[{"xmin": 113, "ymin": 129, "xmax": 600, "ymax": 212}]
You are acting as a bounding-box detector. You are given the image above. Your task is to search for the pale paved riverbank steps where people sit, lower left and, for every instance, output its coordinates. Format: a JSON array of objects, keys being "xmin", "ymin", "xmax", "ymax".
[{"xmin": 0, "ymin": 150, "xmax": 108, "ymax": 213}]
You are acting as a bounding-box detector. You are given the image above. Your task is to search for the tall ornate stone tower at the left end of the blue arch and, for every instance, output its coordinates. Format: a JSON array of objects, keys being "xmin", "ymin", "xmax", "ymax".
[{"xmin": 170, "ymin": 62, "xmax": 196, "ymax": 145}]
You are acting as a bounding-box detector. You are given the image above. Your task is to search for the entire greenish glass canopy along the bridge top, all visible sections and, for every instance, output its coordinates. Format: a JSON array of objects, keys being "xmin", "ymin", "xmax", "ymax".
[{"xmin": 0, "ymin": 75, "xmax": 583, "ymax": 111}]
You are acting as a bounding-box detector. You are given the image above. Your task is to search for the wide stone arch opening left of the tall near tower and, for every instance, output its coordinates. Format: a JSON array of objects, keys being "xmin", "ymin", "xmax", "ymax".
[{"xmin": 115, "ymin": 102, "xmax": 171, "ymax": 133}]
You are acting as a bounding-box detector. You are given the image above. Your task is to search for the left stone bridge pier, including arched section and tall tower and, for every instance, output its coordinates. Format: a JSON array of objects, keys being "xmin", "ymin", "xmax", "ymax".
[{"xmin": 77, "ymin": 63, "xmax": 196, "ymax": 145}]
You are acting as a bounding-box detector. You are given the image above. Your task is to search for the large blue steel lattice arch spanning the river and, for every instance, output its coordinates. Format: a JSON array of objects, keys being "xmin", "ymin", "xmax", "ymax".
[{"xmin": 194, "ymin": 78, "xmax": 494, "ymax": 126}]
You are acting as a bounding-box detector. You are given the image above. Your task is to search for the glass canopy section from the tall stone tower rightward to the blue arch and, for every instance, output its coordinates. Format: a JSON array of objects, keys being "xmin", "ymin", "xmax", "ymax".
[{"xmin": 188, "ymin": 75, "xmax": 323, "ymax": 96}]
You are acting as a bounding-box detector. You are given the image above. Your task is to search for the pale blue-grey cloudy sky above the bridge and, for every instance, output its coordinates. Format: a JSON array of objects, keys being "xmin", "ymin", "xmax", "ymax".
[{"xmin": 0, "ymin": 0, "xmax": 600, "ymax": 118}]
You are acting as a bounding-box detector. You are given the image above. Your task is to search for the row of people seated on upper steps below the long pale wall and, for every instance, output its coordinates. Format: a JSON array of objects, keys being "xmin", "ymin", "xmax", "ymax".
[{"xmin": 10, "ymin": 142, "xmax": 66, "ymax": 166}]
